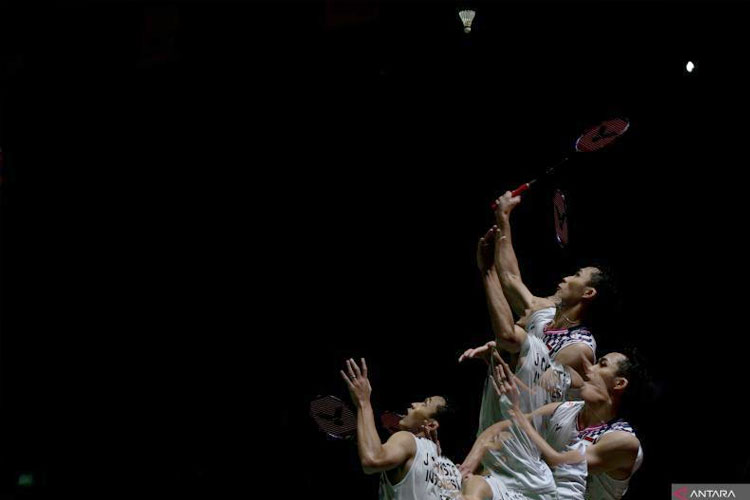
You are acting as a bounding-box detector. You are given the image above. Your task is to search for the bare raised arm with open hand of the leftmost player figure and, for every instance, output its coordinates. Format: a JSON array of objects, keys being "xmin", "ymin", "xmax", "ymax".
[{"xmin": 341, "ymin": 358, "xmax": 417, "ymax": 474}]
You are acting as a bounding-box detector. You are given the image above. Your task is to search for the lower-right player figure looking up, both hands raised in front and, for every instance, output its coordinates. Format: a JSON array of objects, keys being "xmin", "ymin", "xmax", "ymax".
[{"xmin": 461, "ymin": 353, "xmax": 644, "ymax": 500}]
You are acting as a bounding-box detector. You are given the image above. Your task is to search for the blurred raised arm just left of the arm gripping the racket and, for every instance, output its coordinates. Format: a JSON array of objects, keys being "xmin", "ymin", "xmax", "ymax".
[{"xmin": 477, "ymin": 227, "xmax": 526, "ymax": 352}]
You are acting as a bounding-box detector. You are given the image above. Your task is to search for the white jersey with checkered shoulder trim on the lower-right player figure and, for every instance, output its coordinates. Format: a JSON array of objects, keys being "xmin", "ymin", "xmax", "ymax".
[{"xmin": 544, "ymin": 401, "xmax": 643, "ymax": 500}]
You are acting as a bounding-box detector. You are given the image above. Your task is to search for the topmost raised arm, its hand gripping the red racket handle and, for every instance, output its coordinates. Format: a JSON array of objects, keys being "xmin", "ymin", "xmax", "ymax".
[{"xmin": 495, "ymin": 191, "xmax": 554, "ymax": 317}]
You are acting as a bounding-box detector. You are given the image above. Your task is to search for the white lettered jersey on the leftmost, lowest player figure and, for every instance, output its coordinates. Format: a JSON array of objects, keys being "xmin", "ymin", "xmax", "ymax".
[{"xmin": 379, "ymin": 436, "xmax": 461, "ymax": 500}]
